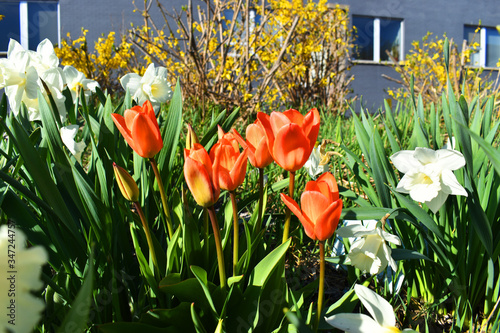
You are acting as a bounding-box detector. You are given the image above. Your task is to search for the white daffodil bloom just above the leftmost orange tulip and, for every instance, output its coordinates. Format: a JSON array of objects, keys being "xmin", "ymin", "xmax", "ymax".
[{"xmin": 120, "ymin": 64, "xmax": 172, "ymax": 112}]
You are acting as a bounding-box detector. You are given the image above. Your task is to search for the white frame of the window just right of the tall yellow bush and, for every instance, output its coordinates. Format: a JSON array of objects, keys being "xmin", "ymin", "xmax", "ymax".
[{"xmin": 351, "ymin": 14, "xmax": 405, "ymax": 64}]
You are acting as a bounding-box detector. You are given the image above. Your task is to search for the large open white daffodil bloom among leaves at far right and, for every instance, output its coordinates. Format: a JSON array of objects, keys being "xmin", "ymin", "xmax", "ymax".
[{"xmin": 391, "ymin": 148, "xmax": 467, "ymax": 213}]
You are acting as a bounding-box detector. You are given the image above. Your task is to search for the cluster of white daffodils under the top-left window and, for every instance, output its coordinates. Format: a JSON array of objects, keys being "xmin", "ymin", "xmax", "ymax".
[{"xmin": 0, "ymin": 39, "xmax": 98, "ymax": 122}]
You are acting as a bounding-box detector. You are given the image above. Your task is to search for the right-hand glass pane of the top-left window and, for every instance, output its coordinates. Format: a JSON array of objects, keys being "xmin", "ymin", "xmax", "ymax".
[{"xmin": 28, "ymin": 2, "xmax": 58, "ymax": 50}]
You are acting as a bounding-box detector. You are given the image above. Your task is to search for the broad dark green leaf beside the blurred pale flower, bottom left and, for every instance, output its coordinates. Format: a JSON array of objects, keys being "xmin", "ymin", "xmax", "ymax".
[{"xmin": 57, "ymin": 255, "xmax": 94, "ymax": 333}]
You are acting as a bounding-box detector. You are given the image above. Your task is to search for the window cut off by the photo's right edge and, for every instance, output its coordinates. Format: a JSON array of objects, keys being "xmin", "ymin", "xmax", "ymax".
[{"xmin": 464, "ymin": 25, "xmax": 500, "ymax": 67}]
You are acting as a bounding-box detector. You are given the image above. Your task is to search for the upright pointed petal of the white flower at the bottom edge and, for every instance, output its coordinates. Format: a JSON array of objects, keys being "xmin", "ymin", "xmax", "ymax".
[{"xmin": 354, "ymin": 284, "xmax": 396, "ymax": 327}]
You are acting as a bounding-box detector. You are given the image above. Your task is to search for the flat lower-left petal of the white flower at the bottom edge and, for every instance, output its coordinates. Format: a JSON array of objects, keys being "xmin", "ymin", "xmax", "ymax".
[{"xmin": 325, "ymin": 309, "xmax": 386, "ymax": 333}]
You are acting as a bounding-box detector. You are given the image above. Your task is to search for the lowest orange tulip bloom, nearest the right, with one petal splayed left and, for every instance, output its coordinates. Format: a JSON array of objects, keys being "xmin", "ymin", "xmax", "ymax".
[{"xmin": 281, "ymin": 172, "xmax": 342, "ymax": 241}]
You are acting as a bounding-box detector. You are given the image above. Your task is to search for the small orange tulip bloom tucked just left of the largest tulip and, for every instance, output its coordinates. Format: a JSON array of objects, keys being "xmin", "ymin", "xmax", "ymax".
[{"xmin": 233, "ymin": 120, "xmax": 273, "ymax": 169}]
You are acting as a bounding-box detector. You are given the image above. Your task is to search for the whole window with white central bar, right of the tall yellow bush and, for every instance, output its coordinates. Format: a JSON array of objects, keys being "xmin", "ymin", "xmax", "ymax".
[{"xmin": 352, "ymin": 15, "xmax": 403, "ymax": 62}]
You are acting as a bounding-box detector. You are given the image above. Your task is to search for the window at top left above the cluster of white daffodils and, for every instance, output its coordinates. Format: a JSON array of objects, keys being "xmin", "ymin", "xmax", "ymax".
[{"xmin": 0, "ymin": 0, "xmax": 60, "ymax": 53}]
